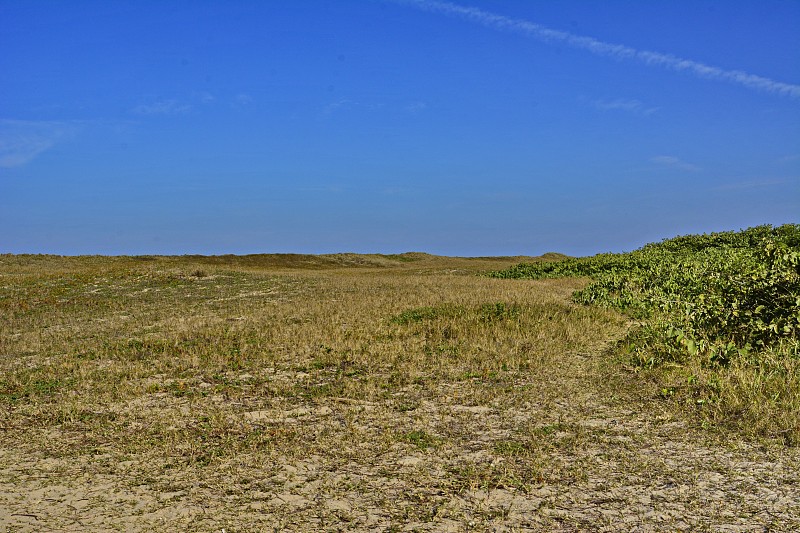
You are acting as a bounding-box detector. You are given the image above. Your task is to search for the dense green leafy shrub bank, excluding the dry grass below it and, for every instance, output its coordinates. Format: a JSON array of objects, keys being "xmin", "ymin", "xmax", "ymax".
[{"xmin": 490, "ymin": 224, "xmax": 800, "ymax": 438}]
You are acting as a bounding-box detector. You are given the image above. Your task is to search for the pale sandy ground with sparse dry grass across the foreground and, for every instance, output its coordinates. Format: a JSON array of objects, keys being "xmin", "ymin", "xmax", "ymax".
[{"xmin": 0, "ymin": 356, "xmax": 800, "ymax": 532}]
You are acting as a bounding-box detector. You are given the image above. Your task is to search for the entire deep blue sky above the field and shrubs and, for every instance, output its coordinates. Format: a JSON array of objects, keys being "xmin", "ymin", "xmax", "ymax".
[{"xmin": 0, "ymin": 0, "xmax": 800, "ymax": 255}]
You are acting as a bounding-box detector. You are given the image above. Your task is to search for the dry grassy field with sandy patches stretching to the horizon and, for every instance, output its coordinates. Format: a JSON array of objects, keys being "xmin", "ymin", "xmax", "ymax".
[{"xmin": 0, "ymin": 253, "xmax": 800, "ymax": 532}]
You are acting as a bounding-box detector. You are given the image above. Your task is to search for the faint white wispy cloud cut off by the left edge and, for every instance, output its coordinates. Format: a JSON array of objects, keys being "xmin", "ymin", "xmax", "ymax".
[{"xmin": 0, "ymin": 119, "xmax": 77, "ymax": 168}]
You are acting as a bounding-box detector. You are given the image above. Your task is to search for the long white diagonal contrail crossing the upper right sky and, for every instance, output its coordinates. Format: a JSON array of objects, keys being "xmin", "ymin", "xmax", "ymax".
[{"xmin": 394, "ymin": 0, "xmax": 800, "ymax": 98}]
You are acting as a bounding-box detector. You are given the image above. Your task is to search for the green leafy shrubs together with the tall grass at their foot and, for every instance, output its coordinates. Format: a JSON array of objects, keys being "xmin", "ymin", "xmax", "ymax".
[{"xmin": 490, "ymin": 224, "xmax": 800, "ymax": 442}]
